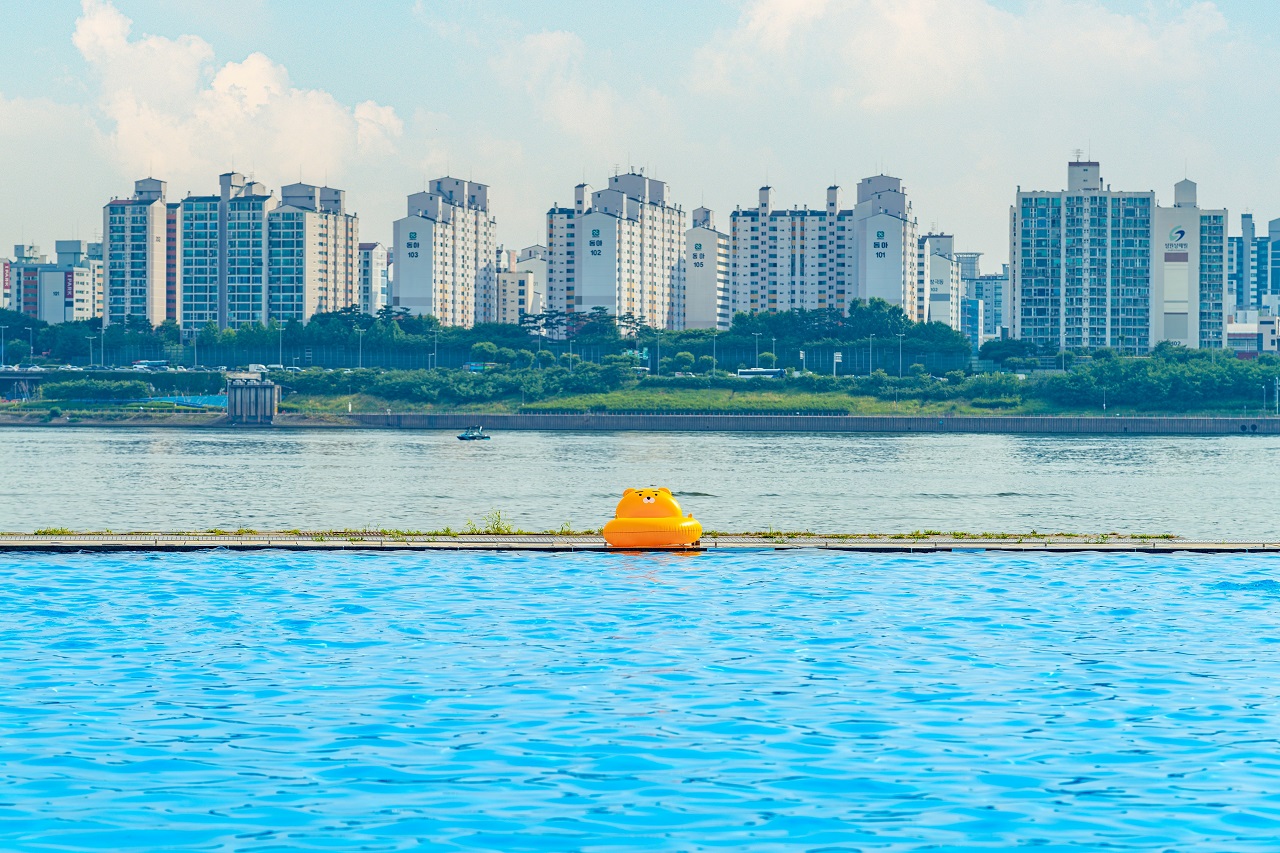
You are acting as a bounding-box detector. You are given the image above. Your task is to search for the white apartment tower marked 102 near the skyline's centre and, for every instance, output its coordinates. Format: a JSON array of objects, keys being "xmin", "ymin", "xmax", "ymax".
[{"xmin": 547, "ymin": 172, "xmax": 685, "ymax": 329}]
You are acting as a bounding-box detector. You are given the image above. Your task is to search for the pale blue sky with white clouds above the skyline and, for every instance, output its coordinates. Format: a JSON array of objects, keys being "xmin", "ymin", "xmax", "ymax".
[{"xmin": 0, "ymin": 0, "xmax": 1280, "ymax": 266}]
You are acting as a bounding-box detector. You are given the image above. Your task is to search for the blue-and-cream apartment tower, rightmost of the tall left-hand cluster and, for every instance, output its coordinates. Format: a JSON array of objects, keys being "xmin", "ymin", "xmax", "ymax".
[{"xmin": 261, "ymin": 183, "xmax": 360, "ymax": 323}]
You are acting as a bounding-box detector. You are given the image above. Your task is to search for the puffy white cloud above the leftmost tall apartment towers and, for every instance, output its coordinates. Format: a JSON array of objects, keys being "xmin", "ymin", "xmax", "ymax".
[{"xmin": 73, "ymin": 0, "xmax": 403, "ymax": 187}]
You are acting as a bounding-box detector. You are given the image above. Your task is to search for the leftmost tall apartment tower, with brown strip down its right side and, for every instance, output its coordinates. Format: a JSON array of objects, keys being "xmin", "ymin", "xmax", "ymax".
[{"xmin": 102, "ymin": 178, "xmax": 177, "ymax": 325}]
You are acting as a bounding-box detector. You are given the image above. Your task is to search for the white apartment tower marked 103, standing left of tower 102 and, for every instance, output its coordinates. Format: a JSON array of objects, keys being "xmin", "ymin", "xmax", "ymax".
[{"xmin": 394, "ymin": 178, "xmax": 497, "ymax": 328}]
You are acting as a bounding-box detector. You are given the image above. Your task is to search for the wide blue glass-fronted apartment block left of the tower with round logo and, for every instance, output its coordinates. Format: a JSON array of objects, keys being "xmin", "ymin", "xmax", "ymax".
[{"xmin": 1009, "ymin": 161, "xmax": 1156, "ymax": 353}]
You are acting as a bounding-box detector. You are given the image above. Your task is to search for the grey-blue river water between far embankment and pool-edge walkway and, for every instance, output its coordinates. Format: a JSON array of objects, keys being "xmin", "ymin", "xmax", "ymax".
[{"xmin": 0, "ymin": 428, "xmax": 1280, "ymax": 539}]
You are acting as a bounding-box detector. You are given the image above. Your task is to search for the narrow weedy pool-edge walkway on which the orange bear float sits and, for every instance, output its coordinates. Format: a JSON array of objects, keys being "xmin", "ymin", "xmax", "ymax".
[{"xmin": 0, "ymin": 532, "xmax": 1280, "ymax": 555}]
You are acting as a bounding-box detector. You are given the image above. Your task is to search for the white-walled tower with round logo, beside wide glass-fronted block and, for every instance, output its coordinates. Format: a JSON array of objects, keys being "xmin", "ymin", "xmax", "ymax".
[{"xmin": 1148, "ymin": 181, "xmax": 1230, "ymax": 347}]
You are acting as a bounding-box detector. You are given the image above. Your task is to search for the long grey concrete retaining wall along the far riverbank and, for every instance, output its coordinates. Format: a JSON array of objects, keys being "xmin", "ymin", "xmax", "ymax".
[{"xmin": 351, "ymin": 414, "xmax": 1280, "ymax": 435}]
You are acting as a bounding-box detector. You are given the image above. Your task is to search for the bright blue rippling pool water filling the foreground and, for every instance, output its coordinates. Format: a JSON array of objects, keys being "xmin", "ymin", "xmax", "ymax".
[{"xmin": 0, "ymin": 552, "xmax": 1280, "ymax": 852}]
